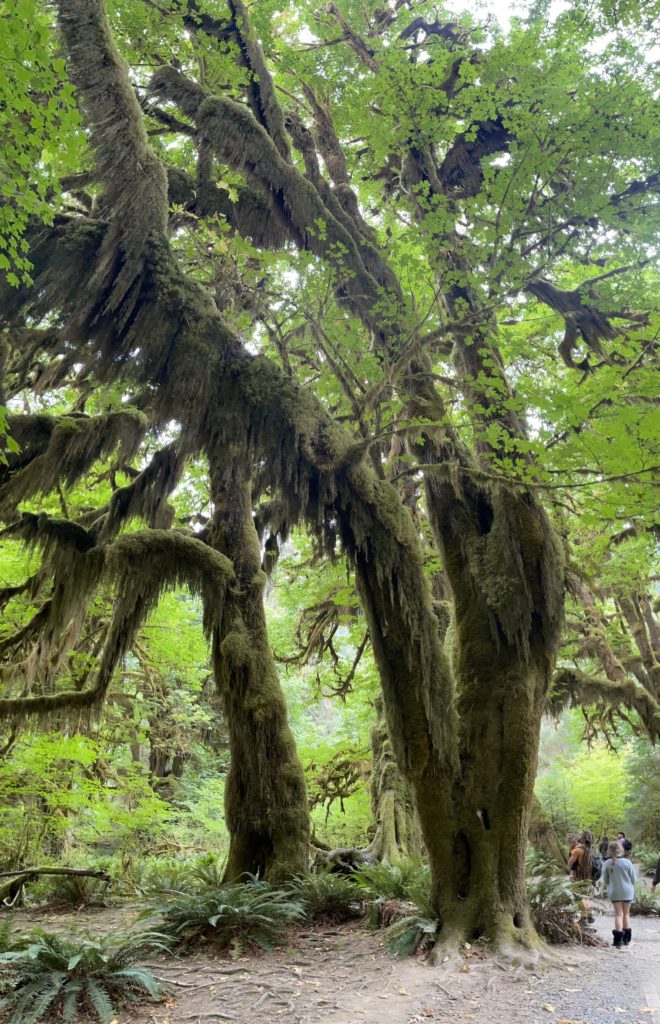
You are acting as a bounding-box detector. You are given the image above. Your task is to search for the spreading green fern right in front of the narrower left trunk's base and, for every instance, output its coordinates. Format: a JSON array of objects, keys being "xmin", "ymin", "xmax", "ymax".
[{"xmin": 145, "ymin": 881, "xmax": 305, "ymax": 950}]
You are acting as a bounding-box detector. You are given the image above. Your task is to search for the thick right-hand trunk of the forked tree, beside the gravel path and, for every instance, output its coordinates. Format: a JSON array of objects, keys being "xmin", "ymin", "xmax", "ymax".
[{"xmin": 417, "ymin": 474, "xmax": 562, "ymax": 942}]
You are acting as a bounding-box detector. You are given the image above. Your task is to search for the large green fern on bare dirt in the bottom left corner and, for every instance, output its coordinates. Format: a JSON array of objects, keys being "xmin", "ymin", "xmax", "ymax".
[{"xmin": 0, "ymin": 932, "xmax": 168, "ymax": 1024}]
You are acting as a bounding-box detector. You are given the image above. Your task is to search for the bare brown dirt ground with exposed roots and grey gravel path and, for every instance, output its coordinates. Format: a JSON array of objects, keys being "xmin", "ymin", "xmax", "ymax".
[{"xmin": 5, "ymin": 904, "xmax": 660, "ymax": 1024}]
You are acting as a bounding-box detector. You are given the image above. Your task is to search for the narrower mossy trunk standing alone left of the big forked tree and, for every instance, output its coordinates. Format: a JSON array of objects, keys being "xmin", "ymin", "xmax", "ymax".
[{"xmin": 205, "ymin": 450, "xmax": 309, "ymax": 881}]
